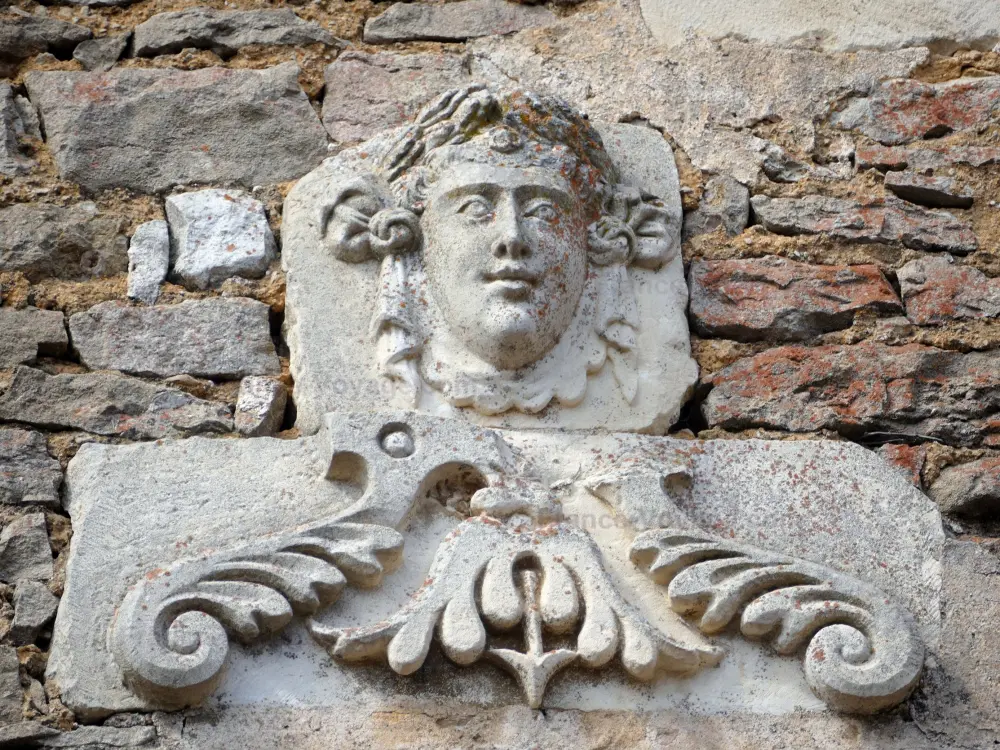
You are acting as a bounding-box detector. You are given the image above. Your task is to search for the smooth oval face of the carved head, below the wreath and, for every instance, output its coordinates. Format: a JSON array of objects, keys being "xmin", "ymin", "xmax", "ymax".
[{"xmin": 421, "ymin": 162, "xmax": 590, "ymax": 370}]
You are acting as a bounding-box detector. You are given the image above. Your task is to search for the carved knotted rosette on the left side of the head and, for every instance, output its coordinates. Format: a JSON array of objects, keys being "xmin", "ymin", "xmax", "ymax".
[{"xmin": 316, "ymin": 175, "xmax": 420, "ymax": 263}]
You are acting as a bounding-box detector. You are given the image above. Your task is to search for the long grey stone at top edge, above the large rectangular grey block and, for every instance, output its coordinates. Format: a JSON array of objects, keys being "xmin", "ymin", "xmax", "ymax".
[{"xmin": 132, "ymin": 7, "xmax": 336, "ymax": 57}]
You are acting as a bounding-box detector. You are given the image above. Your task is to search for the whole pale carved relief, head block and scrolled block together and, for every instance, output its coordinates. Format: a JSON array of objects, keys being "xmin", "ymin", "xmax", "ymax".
[{"xmin": 49, "ymin": 86, "xmax": 943, "ymax": 718}]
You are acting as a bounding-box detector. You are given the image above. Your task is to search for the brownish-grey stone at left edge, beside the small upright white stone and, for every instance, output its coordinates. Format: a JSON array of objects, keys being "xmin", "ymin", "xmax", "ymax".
[{"xmin": 0, "ymin": 203, "xmax": 128, "ymax": 282}]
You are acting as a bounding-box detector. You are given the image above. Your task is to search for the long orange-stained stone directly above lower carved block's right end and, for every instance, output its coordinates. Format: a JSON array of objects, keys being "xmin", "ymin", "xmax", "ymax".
[{"xmin": 703, "ymin": 343, "xmax": 1000, "ymax": 445}]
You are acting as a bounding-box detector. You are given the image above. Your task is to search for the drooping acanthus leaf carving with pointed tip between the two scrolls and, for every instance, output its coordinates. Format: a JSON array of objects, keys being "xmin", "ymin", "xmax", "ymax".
[{"xmin": 309, "ymin": 515, "xmax": 722, "ymax": 708}]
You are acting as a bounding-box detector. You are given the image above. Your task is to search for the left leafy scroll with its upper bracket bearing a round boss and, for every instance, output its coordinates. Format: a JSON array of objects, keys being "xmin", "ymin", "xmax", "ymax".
[{"xmin": 109, "ymin": 412, "xmax": 513, "ymax": 707}]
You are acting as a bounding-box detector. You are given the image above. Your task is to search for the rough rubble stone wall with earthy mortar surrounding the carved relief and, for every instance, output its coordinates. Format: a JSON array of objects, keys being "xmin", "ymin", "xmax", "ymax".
[{"xmin": 0, "ymin": 0, "xmax": 1000, "ymax": 748}]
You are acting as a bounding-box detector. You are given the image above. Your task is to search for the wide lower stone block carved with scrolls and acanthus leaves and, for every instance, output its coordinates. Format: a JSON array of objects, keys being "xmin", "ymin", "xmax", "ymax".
[{"xmin": 50, "ymin": 412, "xmax": 942, "ymax": 715}]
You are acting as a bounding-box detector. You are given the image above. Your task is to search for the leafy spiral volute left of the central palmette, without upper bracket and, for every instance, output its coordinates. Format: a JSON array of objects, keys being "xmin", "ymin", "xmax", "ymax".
[{"xmin": 111, "ymin": 522, "xmax": 403, "ymax": 705}]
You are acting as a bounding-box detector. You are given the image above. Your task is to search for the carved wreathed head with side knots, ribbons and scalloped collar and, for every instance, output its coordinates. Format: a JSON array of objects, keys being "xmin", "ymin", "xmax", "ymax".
[{"xmin": 282, "ymin": 86, "xmax": 686, "ymax": 432}]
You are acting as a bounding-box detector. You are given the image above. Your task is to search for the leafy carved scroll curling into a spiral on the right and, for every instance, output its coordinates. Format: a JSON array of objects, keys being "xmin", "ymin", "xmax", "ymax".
[{"xmin": 631, "ymin": 530, "xmax": 924, "ymax": 713}]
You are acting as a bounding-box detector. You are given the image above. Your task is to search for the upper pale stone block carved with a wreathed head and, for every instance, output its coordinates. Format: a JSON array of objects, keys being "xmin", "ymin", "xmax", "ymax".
[{"xmin": 283, "ymin": 86, "xmax": 696, "ymax": 432}]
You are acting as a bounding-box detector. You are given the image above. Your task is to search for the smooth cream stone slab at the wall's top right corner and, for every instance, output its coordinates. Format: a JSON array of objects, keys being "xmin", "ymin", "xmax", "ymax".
[{"xmin": 642, "ymin": 0, "xmax": 1000, "ymax": 51}]
